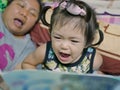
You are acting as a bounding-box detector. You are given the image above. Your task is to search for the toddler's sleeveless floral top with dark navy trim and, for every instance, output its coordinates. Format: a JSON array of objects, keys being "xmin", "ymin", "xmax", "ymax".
[{"xmin": 42, "ymin": 42, "xmax": 96, "ymax": 73}]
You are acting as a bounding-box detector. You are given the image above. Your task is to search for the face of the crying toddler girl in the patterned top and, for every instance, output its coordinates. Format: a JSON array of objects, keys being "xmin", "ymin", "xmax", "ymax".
[{"xmin": 51, "ymin": 24, "xmax": 86, "ymax": 64}]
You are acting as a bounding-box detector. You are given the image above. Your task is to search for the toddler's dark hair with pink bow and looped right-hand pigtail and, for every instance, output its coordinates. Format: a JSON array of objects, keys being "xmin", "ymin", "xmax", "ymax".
[{"xmin": 50, "ymin": 0, "xmax": 104, "ymax": 46}]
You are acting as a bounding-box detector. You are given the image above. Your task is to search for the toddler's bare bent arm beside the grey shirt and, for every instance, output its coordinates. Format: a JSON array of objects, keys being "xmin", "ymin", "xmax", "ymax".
[{"xmin": 22, "ymin": 44, "xmax": 46, "ymax": 69}]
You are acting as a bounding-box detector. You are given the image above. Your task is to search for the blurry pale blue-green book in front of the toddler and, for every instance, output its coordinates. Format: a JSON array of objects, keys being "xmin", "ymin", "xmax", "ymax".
[{"xmin": 0, "ymin": 70, "xmax": 120, "ymax": 90}]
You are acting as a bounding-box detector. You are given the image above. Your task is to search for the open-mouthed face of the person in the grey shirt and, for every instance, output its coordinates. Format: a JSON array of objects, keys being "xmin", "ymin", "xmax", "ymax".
[{"xmin": 3, "ymin": 0, "xmax": 40, "ymax": 36}]
